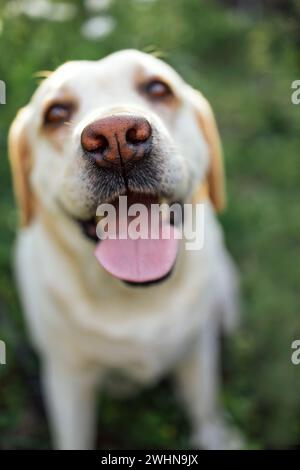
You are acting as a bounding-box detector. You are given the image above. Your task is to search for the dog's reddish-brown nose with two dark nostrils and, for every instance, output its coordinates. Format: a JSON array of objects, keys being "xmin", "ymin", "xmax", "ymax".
[{"xmin": 81, "ymin": 114, "xmax": 152, "ymax": 168}]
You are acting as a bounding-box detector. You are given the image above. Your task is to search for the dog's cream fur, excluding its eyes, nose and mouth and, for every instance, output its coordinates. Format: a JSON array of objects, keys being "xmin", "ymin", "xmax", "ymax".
[{"xmin": 10, "ymin": 51, "xmax": 239, "ymax": 449}]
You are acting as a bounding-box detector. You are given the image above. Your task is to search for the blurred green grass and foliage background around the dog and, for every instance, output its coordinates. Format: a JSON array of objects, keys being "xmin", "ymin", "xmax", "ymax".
[{"xmin": 0, "ymin": 0, "xmax": 300, "ymax": 448}]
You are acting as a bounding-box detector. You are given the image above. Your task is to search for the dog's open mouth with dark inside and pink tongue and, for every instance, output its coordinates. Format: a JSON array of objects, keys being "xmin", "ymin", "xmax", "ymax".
[{"xmin": 79, "ymin": 193, "xmax": 179, "ymax": 286}]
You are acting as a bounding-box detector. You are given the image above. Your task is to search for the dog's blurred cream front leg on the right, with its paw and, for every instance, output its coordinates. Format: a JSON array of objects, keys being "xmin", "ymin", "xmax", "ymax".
[{"xmin": 176, "ymin": 314, "xmax": 241, "ymax": 449}]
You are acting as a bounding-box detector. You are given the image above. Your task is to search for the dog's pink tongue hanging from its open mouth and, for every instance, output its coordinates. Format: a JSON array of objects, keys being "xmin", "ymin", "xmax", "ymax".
[{"xmin": 95, "ymin": 196, "xmax": 179, "ymax": 283}]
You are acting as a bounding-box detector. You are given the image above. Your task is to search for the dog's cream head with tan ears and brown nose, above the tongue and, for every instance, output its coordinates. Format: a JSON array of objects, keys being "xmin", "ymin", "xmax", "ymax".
[{"xmin": 9, "ymin": 50, "xmax": 224, "ymax": 281}]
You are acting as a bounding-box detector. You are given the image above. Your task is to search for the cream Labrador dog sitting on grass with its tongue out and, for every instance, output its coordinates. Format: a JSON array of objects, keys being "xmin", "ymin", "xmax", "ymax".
[{"xmin": 9, "ymin": 50, "xmax": 240, "ymax": 449}]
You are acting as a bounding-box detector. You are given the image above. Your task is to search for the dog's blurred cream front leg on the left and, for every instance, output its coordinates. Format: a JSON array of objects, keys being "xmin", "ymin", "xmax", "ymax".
[{"xmin": 43, "ymin": 358, "xmax": 99, "ymax": 449}]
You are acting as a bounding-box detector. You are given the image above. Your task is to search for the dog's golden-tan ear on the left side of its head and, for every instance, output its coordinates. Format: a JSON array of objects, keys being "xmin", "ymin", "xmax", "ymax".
[{"xmin": 8, "ymin": 108, "xmax": 34, "ymax": 226}]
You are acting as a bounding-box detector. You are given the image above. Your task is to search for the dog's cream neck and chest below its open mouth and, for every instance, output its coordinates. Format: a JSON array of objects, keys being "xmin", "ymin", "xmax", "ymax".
[{"xmin": 18, "ymin": 223, "xmax": 216, "ymax": 382}]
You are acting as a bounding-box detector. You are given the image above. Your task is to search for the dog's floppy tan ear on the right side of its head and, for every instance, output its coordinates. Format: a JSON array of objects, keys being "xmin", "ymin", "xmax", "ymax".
[{"xmin": 189, "ymin": 89, "xmax": 226, "ymax": 212}]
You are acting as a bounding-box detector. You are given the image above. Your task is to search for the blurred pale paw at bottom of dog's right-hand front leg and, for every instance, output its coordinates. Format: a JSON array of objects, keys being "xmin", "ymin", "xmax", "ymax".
[{"xmin": 191, "ymin": 418, "xmax": 245, "ymax": 450}]
